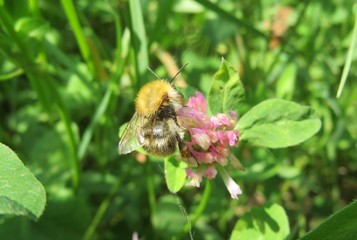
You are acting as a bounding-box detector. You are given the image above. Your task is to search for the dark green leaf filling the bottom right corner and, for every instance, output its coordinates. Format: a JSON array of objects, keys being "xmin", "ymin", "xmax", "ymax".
[{"xmin": 301, "ymin": 201, "xmax": 357, "ymax": 240}]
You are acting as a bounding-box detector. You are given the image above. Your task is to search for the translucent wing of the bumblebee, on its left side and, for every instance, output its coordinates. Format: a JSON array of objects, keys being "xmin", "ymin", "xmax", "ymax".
[{"xmin": 118, "ymin": 113, "xmax": 144, "ymax": 154}]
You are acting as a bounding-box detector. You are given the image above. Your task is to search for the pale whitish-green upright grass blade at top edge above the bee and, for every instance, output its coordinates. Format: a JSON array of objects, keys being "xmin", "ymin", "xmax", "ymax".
[{"xmin": 129, "ymin": 0, "xmax": 149, "ymax": 85}]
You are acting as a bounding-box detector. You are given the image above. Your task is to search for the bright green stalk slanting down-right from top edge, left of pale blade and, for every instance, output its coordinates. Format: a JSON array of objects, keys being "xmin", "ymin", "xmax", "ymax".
[{"xmin": 61, "ymin": 0, "xmax": 95, "ymax": 77}]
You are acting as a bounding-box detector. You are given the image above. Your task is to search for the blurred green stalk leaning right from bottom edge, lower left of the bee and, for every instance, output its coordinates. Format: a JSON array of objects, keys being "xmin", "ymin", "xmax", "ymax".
[{"xmin": 83, "ymin": 180, "xmax": 121, "ymax": 240}]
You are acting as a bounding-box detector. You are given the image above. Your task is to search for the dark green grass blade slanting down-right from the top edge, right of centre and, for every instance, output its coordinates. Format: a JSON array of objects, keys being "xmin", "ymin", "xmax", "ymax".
[{"xmin": 196, "ymin": 0, "xmax": 268, "ymax": 40}]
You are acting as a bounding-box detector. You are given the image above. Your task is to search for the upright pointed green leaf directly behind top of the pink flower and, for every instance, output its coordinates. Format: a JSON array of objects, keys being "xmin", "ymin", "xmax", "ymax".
[{"xmin": 208, "ymin": 59, "xmax": 244, "ymax": 114}]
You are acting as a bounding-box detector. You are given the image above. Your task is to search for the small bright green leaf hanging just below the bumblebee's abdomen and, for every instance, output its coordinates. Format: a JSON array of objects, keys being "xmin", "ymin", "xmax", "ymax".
[{"xmin": 165, "ymin": 157, "xmax": 187, "ymax": 193}]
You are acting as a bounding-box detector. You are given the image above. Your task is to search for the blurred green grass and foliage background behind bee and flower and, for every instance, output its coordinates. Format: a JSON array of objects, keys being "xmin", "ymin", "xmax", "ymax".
[{"xmin": 0, "ymin": 0, "xmax": 357, "ymax": 239}]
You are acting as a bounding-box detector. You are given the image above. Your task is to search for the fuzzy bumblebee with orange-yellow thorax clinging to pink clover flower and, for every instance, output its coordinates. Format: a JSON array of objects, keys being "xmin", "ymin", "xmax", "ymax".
[{"xmin": 118, "ymin": 64, "xmax": 191, "ymax": 159}]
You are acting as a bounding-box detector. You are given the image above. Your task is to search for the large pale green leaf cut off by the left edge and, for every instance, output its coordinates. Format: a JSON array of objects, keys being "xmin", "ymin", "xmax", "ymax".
[{"xmin": 0, "ymin": 143, "xmax": 46, "ymax": 220}]
